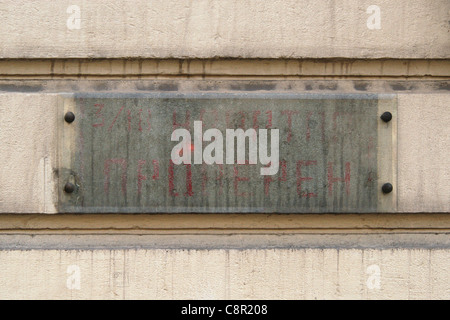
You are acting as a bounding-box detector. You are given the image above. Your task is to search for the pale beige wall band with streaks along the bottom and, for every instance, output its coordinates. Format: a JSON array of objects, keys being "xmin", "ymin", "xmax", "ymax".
[{"xmin": 0, "ymin": 249, "xmax": 450, "ymax": 300}]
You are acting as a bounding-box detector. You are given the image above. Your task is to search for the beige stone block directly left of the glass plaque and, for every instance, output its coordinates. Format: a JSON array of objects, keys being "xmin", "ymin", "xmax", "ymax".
[{"xmin": 0, "ymin": 92, "xmax": 57, "ymax": 213}]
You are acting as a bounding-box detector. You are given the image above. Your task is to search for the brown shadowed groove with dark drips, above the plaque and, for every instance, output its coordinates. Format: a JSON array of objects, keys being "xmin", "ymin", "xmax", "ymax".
[{"xmin": 0, "ymin": 59, "xmax": 450, "ymax": 79}]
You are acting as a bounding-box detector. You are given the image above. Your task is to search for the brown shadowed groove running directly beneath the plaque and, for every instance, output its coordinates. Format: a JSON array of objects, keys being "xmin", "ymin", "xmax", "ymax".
[{"xmin": 0, "ymin": 214, "xmax": 450, "ymax": 234}]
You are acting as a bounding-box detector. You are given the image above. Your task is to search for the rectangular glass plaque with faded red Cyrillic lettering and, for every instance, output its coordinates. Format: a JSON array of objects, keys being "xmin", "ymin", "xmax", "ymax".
[{"xmin": 58, "ymin": 93, "xmax": 397, "ymax": 213}]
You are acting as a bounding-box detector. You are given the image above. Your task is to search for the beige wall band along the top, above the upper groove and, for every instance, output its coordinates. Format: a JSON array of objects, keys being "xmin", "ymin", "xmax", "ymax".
[{"xmin": 0, "ymin": 0, "xmax": 450, "ymax": 58}]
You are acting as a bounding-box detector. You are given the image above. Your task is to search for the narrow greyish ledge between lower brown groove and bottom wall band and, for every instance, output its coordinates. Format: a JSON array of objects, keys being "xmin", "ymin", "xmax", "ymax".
[{"xmin": 0, "ymin": 233, "xmax": 450, "ymax": 251}]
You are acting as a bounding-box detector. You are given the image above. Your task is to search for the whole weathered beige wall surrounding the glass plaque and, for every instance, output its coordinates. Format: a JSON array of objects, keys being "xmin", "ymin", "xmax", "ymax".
[{"xmin": 0, "ymin": 0, "xmax": 450, "ymax": 299}]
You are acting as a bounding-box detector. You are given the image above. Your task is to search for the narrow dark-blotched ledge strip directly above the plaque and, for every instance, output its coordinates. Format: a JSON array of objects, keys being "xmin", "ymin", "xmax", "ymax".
[{"xmin": 0, "ymin": 77, "xmax": 450, "ymax": 94}]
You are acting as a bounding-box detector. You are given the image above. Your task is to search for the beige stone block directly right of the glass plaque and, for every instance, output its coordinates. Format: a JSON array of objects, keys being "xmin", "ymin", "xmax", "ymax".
[{"xmin": 398, "ymin": 94, "xmax": 450, "ymax": 212}]
